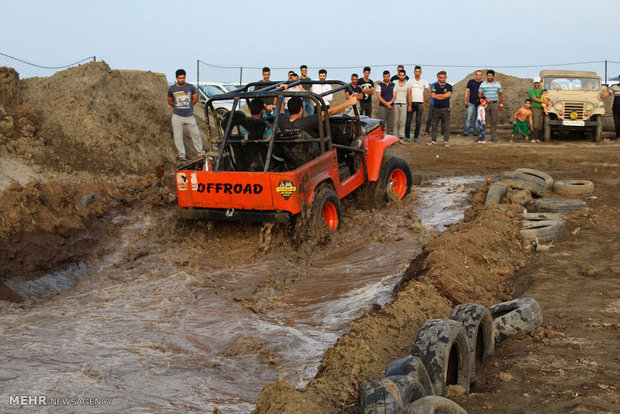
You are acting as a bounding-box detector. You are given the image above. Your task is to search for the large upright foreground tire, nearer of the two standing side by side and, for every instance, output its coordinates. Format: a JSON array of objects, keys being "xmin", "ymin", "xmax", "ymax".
[{"xmin": 411, "ymin": 319, "xmax": 470, "ymax": 396}]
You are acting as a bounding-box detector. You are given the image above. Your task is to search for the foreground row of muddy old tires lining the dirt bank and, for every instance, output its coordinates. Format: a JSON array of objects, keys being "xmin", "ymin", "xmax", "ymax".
[{"xmin": 357, "ymin": 298, "xmax": 542, "ymax": 414}]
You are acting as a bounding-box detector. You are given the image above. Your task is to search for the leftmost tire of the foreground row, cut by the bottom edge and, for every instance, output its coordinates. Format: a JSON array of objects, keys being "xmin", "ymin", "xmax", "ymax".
[{"xmin": 357, "ymin": 375, "xmax": 425, "ymax": 414}]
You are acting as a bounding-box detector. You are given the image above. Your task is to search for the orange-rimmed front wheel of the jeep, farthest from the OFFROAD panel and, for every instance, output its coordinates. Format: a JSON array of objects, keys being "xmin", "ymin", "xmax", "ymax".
[{"xmin": 375, "ymin": 155, "xmax": 413, "ymax": 206}]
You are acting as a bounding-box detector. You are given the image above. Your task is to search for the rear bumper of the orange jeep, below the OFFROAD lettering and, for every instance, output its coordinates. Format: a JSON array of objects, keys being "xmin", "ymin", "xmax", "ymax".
[{"xmin": 179, "ymin": 208, "xmax": 292, "ymax": 224}]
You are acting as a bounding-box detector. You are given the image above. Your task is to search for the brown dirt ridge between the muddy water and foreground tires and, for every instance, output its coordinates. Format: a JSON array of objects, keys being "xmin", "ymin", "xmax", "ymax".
[{"xmin": 255, "ymin": 200, "xmax": 529, "ymax": 413}]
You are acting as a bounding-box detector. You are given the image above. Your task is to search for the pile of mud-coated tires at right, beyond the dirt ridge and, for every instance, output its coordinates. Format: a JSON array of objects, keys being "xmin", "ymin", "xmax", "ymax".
[{"xmin": 485, "ymin": 168, "xmax": 594, "ymax": 246}]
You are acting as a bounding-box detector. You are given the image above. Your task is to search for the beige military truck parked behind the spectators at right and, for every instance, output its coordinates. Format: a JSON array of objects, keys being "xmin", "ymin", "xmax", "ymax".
[{"xmin": 540, "ymin": 70, "xmax": 607, "ymax": 142}]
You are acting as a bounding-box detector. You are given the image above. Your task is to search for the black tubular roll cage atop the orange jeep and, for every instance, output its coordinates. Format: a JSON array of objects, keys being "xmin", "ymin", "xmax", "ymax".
[{"xmin": 205, "ymin": 79, "xmax": 361, "ymax": 172}]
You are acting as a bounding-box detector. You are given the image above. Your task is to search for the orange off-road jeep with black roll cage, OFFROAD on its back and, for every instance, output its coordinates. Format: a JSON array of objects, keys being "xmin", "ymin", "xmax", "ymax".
[{"xmin": 176, "ymin": 80, "xmax": 412, "ymax": 231}]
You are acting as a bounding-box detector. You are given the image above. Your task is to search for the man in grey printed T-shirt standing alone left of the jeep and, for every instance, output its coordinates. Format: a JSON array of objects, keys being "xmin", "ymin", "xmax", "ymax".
[{"xmin": 168, "ymin": 69, "xmax": 204, "ymax": 163}]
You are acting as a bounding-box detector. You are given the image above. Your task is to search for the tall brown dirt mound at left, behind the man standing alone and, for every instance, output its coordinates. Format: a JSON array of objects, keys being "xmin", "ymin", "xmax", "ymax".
[{"xmin": 0, "ymin": 62, "xmax": 204, "ymax": 175}]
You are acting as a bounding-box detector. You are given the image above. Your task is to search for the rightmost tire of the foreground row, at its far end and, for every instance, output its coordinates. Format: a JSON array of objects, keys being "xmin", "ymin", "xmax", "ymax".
[{"xmin": 489, "ymin": 298, "xmax": 543, "ymax": 343}]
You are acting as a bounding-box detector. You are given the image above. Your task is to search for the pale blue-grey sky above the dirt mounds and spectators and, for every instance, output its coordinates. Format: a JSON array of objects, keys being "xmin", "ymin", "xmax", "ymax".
[{"xmin": 0, "ymin": 0, "xmax": 620, "ymax": 82}]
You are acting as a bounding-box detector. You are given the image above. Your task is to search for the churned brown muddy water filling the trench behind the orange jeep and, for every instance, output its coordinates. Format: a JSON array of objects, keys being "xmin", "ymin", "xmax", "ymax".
[{"xmin": 0, "ymin": 177, "xmax": 482, "ymax": 413}]
